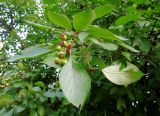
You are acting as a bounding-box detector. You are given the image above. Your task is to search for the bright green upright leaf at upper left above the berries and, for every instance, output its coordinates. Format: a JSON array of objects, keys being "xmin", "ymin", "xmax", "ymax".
[{"xmin": 48, "ymin": 12, "xmax": 72, "ymax": 30}]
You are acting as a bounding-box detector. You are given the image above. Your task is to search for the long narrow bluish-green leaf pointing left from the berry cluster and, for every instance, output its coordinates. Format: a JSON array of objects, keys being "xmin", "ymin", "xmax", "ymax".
[{"xmin": 7, "ymin": 45, "xmax": 51, "ymax": 62}]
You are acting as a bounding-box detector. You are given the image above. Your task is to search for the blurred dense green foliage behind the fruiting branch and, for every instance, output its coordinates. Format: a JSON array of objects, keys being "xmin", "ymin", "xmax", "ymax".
[{"xmin": 0, "ymin": 0, "xmax": 160, "ymax": 116}]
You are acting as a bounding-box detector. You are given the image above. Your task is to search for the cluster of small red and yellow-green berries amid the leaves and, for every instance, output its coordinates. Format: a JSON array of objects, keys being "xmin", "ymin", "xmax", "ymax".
[{"xmin": 55, "ymin": 33, "xmax": 72, "ymax": 66}]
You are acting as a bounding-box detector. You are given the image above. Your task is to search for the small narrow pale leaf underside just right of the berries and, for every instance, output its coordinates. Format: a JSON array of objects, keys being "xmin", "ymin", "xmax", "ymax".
[{"xmin": 92, "ymin": 39, "xmax": 118, "ymax": 51}]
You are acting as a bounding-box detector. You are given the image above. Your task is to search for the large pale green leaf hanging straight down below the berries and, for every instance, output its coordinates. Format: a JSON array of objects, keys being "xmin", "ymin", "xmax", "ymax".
[{"xmin": 59, "ymin": 59, "xmax": 91, "ymax": 107}]
